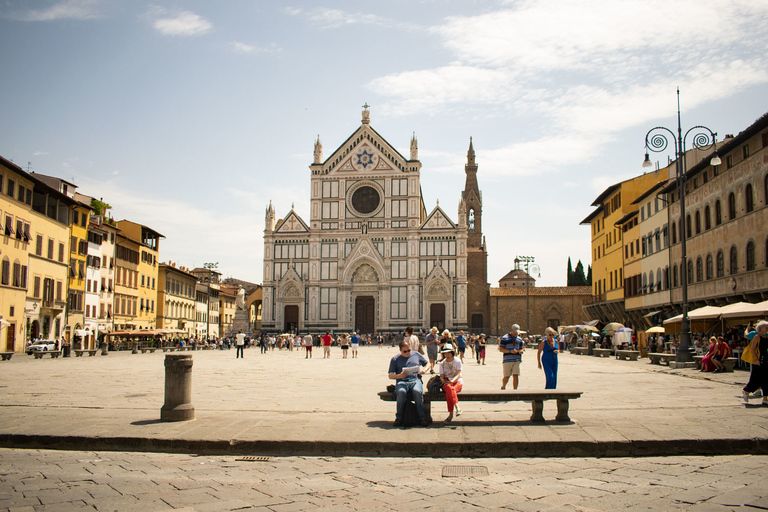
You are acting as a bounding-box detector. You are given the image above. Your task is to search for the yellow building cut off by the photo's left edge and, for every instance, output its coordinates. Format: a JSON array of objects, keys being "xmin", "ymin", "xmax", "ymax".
[{"xmin": 0, "ymin": 157, "xmax": 34, "ymax": 352}]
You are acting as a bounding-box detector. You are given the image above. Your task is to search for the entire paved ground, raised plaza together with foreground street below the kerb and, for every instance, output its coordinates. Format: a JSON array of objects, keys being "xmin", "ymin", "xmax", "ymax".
[{"xmin": 0, "ymin": 346, "xmax": 768, "ymax": 512}]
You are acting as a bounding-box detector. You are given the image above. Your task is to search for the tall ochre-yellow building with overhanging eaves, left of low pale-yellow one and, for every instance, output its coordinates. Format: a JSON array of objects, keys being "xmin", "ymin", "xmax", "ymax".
[{"xmin": 117, "ymin": 220, "xmax": 163, "ymax": 329}]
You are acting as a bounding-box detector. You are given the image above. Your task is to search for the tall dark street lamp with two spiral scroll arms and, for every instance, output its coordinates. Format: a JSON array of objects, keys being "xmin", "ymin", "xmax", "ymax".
[{"xmin": 643, "ymin": 87, "xmax": 722, "ymax": 362}]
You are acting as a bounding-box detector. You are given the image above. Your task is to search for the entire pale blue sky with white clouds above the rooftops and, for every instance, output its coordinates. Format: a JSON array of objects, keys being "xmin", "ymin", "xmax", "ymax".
[{"xmin": 0, "ymin": 0, "xmax": 768, "ymax": 286}]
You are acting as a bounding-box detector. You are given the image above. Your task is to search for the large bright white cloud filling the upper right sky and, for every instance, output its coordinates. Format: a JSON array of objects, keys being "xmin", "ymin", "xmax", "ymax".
[{"xmin": 368, "ymin": 0, "xmax": 768, "ymax": 175}]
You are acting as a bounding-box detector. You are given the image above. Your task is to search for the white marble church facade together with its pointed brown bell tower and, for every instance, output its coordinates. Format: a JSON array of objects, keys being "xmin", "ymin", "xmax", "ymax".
[{"xmin": 262, "ymin": 105, "xmax": 490, "ymax": 334}]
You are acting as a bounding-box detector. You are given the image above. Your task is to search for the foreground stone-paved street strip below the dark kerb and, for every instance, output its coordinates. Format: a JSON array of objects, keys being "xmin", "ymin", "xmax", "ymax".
[{"xmin": 0, "ymin": 449, "xmax": 768, "ymax": 512}]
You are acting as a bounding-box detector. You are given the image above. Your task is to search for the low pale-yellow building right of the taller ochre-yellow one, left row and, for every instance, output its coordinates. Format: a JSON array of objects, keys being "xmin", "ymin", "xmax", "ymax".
[{"xmin": 157, "ymin": 262, "xmax": 197, "ymax": 337}]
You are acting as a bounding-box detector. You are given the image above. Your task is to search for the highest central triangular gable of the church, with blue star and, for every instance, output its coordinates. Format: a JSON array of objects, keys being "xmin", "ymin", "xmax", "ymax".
[{"xmin": 312, "ymin": 125, "xmax": 421, "ymax": 174}]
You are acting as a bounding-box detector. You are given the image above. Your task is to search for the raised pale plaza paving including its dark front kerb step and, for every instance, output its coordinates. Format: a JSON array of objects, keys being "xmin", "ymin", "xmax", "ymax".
[{"xmin": 0, "ymin": 346, "xmax": 768, "ymax": 457}]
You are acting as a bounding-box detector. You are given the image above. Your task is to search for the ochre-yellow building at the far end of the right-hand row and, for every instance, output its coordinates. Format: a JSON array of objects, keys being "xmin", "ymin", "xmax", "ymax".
[{"xmin": 581, "ymin": 169, "xmax": 667, "ymax": 324}]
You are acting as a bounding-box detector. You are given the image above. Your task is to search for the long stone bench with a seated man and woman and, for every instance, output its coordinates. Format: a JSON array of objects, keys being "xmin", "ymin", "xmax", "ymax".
[{"xmin": 378, "ymin": 389, "xmax": 582, "ymax": 423}]
